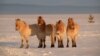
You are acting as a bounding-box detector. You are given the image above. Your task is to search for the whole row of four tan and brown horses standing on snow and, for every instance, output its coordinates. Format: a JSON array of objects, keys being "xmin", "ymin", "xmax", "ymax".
[{"xmin": 15, "ymin": 16, "xmax": 79, "ymax": 48}]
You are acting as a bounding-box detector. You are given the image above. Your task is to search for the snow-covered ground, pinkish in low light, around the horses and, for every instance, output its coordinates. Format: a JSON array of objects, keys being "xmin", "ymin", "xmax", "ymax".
[{"xmin": 0, "ymin": 14, "xmax": 100, "ymax": 56}]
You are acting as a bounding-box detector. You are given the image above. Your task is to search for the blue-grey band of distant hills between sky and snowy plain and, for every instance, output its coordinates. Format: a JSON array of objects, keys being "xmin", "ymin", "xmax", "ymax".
[{"xmin": 0, "ymin": 5, "xmax": 100, "ymax": 14}]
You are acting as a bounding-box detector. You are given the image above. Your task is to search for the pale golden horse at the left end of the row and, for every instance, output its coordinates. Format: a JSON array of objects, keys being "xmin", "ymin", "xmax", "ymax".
[{"xmin": 15, "ymin": 19, "xmax": 31, "ymax": 48}]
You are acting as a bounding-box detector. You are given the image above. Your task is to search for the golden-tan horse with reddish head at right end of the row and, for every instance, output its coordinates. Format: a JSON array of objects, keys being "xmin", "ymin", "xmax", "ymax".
[{"xmin": 66, "ymin": 17, "xmax": 79, "ymax": 47}]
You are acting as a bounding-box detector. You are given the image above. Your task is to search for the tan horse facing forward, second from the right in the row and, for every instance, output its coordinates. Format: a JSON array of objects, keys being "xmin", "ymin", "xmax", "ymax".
[{"xmin": 55, "ymin": 20, "xmax": 66, "ymax": 48}]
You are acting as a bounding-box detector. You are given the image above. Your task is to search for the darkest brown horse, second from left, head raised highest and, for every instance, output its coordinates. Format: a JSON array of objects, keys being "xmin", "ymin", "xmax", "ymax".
[{"xmin": 37, "ymin": 16, "xmax": 55, "ymax": 47}]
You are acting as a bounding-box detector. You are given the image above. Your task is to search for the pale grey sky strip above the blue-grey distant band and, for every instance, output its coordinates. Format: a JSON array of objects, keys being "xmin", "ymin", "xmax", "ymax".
[{"xmin": 0, "ymin": 0, "xmax": 100, "ymax": 6}]
